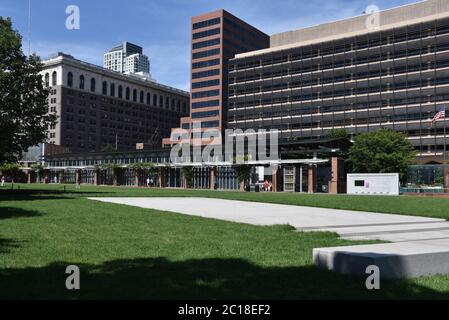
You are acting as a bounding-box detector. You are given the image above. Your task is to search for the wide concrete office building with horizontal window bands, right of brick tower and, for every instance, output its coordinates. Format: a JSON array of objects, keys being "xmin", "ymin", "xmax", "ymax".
[{"xmin": 229, "ymin": 0, "xmax": 449, "ymax": 163}]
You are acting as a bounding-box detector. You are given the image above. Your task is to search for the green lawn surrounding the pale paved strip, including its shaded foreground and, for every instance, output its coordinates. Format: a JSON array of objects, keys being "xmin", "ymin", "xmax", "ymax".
[{"xmin": 0, "ymin": 185, "xmax": 449, "ymax": 299}]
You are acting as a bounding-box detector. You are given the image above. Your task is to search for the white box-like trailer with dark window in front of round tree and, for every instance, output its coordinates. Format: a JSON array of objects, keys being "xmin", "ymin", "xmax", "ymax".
[{"xmin": 346, "ymin": 173, "xmax": 400, "ymax": 195}]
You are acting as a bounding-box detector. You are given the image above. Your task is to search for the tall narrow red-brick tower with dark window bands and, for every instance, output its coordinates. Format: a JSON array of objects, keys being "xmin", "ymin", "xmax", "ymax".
[{"xmin": 164, "ymin": 10, "xmax": 269, "ymax": 145}]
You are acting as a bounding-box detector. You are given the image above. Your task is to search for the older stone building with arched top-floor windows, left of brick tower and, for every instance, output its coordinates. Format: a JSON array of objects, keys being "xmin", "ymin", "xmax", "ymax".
[{"xmin": 41, "ymin": 53, "xmax": 189, "ymax": 152}]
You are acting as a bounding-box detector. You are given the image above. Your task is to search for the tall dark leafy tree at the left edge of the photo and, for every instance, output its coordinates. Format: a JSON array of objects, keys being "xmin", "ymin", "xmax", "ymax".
[{"xmin": 0, "ymin": 17, "xmax": 56, "ymax": 163}]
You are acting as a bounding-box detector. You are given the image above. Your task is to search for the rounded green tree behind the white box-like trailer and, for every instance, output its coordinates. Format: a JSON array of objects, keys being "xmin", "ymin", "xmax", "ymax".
[{"xmin": 347, "ymin": 129, "xmax": 416, "ymax": 180}]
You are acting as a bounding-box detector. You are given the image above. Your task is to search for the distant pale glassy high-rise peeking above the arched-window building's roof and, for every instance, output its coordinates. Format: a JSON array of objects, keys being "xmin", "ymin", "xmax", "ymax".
[{"xmin": 103, "ymin": 41, "xmax": 150, "ymax": 76}]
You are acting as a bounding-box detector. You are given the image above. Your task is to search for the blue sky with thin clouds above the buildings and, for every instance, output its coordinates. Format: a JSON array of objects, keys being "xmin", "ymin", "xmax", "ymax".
[{"xmin": 0, "ymin": 0, "xmax": 417, "ymax": 90}]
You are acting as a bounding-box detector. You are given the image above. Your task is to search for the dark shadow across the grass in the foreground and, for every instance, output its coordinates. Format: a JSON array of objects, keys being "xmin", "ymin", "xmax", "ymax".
[{"xmin": 0, "ymin": 257, "xmax": 449, "ymax": 299}]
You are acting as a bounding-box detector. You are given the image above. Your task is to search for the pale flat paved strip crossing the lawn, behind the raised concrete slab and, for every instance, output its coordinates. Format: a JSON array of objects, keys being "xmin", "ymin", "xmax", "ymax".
[{"xmin": 91, "ymin": 198, "xmax": 449, "ymax": 241}]
